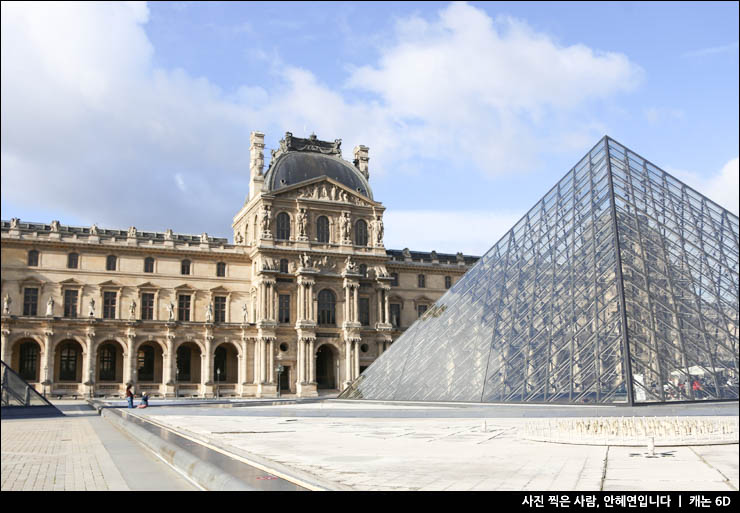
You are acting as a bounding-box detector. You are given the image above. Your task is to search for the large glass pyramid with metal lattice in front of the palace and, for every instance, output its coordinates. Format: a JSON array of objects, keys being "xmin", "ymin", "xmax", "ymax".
[{"xmin": 340, "ymin": 137, "xmax": 739, "ymax": 404}]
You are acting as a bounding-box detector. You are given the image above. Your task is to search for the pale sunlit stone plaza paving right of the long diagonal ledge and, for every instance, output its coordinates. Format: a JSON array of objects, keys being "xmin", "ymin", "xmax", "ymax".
[{"xmin": 136, "ymin": 404, "xmax": 738, "ymax": 491}]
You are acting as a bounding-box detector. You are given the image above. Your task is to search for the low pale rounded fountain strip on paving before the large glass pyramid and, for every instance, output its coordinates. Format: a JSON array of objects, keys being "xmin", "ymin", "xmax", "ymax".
[{"xmin": 519, "ymin": 417, "xmax": 738, "ymax": 447}]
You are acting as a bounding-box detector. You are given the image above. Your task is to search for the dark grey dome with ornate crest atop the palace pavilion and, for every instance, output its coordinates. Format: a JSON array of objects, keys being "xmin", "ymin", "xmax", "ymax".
[{"xmin": 263, "ymin": 132, "xmax": 373, "ymax": 199}]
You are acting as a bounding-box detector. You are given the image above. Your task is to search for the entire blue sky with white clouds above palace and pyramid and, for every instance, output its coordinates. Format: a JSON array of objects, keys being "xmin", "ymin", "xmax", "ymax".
[{"xmin": 1, "ymin": 2, "xmax": 739, "ymax": 254}]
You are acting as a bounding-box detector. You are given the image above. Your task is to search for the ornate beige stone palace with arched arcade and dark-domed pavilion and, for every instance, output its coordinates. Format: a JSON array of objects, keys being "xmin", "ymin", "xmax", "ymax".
[{"xmin": 1, "ymin": 132, "xmax": 477, "ymax": 397}]
